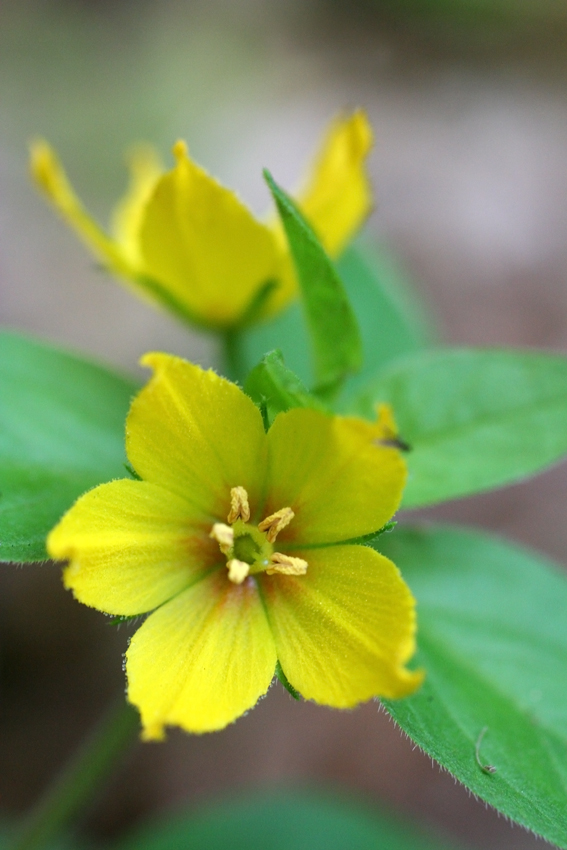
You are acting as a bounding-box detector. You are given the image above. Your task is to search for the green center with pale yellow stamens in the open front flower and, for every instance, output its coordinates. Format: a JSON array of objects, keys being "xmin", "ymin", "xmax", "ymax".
[{"xmin": 210, "ymin": 487, "xmax": 307, "ymax": 584}]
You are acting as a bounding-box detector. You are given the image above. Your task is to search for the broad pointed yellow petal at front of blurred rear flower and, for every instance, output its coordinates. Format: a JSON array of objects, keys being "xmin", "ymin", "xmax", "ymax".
[{"xmin": 140, "ymin": 142, "xmax": 280, "ymax": 327}]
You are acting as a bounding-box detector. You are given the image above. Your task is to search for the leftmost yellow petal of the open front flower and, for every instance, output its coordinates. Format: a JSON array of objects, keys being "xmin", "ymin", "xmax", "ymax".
[{"xmin": 47, "ymin": 480, "xmax": 215, "ymax": 615}]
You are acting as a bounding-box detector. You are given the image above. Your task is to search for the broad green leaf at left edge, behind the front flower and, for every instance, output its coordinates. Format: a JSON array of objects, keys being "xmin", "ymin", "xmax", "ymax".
[{"xmin": 0, "ymin": 331, "xmax": 138, "ymax": 562}]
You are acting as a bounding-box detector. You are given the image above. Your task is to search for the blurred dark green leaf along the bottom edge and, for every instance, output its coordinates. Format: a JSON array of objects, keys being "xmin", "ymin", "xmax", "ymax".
[{"xmin": 116, "ymin": 788, "xmax": 454, "ymax": 850}]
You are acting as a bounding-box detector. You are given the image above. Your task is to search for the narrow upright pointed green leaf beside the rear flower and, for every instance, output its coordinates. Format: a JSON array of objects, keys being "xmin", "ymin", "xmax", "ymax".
[{"xmin": 264, "ymin": 171, "xmax": 362, "ymax": 395}]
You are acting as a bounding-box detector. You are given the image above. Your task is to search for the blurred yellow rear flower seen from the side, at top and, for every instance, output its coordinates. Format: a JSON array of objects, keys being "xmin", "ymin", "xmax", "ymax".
[{"xmin": 31, "ymin": 111, "xmax": 372, "ymax": 330}]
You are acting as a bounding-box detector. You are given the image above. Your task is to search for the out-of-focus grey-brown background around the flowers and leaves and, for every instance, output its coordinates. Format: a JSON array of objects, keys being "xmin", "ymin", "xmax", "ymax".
[{"xmin": 0, "ymin": 0, "xmax": 567, "ymax": 850}]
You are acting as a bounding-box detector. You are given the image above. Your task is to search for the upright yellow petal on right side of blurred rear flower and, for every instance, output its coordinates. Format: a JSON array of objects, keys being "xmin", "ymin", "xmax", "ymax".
[{"xmin": 298, "ymin": 110, "xmax": 373, "ymax": 257}]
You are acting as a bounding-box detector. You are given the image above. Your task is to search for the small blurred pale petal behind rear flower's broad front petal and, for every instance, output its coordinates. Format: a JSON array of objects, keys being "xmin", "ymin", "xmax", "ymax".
[{"xmin": 112, "ymin": 145, "xmax": 164, "ymax": 268}]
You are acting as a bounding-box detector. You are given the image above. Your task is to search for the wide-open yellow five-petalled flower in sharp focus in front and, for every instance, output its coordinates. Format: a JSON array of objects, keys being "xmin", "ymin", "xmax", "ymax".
[{"xmin": 47, "ymin": 354, "xmax": 422, "ymax": 739}]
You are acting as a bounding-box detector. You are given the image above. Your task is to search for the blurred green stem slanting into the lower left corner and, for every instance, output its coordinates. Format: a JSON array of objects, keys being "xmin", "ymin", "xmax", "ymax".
[{"xmin": 13, "ymin": 697, "xmax": 140, "ymax": 850}]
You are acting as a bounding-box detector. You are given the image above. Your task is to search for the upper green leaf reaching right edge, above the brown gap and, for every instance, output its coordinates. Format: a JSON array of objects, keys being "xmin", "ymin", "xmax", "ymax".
[{"xmin": 352, "ymin": 349, "xmax": 567, "ymax": 508}]
